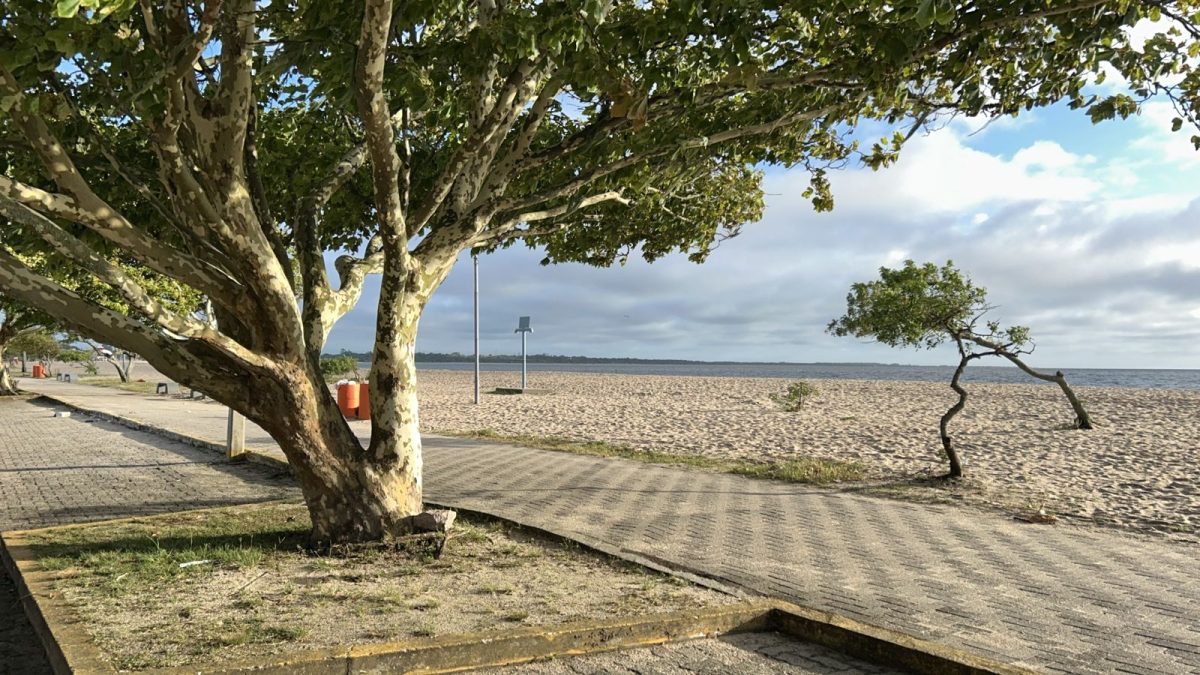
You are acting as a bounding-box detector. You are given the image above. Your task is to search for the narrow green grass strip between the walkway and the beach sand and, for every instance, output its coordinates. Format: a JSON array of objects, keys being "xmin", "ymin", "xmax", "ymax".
[{"xmin": 448, "ymin": 429, "xmax": 866, "ymax": 485}]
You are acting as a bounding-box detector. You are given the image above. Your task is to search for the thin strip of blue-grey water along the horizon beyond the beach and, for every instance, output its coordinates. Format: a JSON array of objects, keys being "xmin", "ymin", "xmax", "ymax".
[{"xmin": 400, "ymin": 363, "xmax": 1200, "ymax": 389}]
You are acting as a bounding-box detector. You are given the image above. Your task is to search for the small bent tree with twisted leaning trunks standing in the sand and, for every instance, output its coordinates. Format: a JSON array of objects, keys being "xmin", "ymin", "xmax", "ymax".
[{"xmin": 828, "ymin": 261, "xmax": 1092, "ymax": 478}]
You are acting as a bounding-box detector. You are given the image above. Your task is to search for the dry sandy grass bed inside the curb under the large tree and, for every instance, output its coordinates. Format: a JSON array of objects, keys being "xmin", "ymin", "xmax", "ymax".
[{"xmin": 31, "ymin": 504, "xmax": 736, "ymax": 670}]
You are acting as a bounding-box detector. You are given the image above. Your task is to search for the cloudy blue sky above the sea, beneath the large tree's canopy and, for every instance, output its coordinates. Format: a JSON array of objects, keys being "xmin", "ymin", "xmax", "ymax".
[{"xmin": 328, "ymin": 97, "xmax": 1200, "ymax": 369}]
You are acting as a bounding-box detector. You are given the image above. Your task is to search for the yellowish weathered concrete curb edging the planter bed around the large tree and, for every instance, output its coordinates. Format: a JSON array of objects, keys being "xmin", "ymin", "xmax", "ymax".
[{"xmin": 0, "ymin": 502, "xmax": 1032, "ymax": 675}]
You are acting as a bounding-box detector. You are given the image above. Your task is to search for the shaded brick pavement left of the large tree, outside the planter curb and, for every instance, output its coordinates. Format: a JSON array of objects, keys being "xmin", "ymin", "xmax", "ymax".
[{"xmin": 0, "ymin": 399, "xmax": 299, "ymax": 675}]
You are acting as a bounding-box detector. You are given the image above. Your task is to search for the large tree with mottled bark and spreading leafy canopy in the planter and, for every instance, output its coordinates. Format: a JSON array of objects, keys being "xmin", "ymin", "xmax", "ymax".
[{"xmin": 0, "ymin": 0, "xmax": 1198, "ymax": 542}]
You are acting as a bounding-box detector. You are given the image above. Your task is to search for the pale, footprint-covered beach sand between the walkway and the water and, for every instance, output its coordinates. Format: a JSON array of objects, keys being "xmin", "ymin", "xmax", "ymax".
[{"xmin": 420, "ymin": 369, "xmax": 1200, "ymax": 540}]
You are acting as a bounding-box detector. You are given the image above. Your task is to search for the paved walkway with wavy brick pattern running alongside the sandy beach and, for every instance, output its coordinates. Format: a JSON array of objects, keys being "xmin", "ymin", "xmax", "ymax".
[{"xmin": 14, "ymin": 381, "xmax": 1200, "ymax": 674}]
